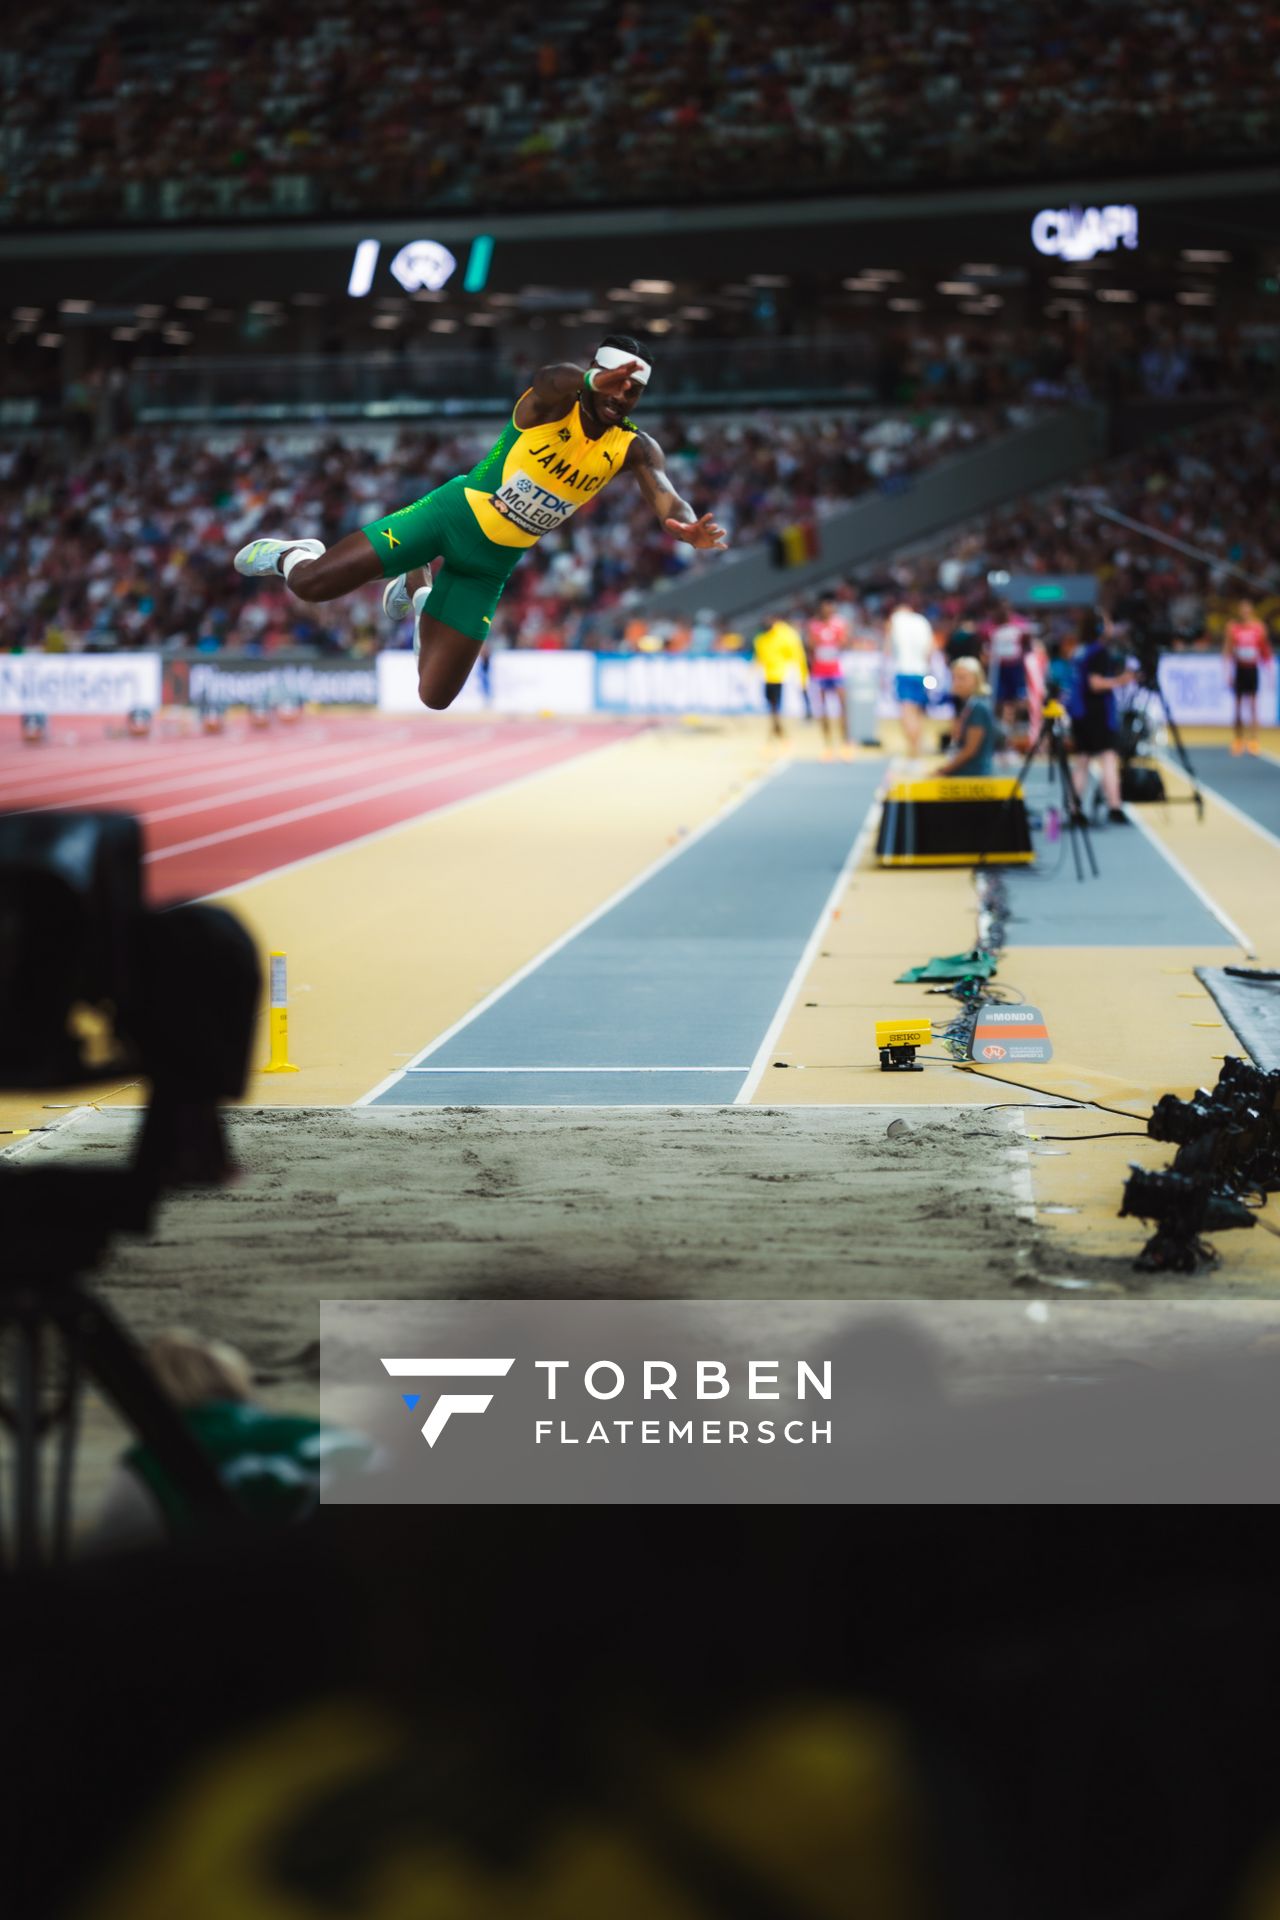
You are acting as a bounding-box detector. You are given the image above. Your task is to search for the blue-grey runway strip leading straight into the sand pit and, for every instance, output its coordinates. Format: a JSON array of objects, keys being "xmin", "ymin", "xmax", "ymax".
[{"xmin": 370, "ymin": 762, "xmax": 883, "ymax": 1106}]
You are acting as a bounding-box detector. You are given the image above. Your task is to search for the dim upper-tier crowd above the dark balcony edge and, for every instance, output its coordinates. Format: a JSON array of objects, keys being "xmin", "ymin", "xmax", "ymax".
[{"xmin": 0, "ymin": 0, "xmax": 1280, "ymax": 225}]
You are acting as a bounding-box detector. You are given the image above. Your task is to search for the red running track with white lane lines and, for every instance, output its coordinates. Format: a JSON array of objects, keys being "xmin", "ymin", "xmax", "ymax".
[{"xmin": 0, "ymin": 714, "xmax": 643, "ymax": 900}]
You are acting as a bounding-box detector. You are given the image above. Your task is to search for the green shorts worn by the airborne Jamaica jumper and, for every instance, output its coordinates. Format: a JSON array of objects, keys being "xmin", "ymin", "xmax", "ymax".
[{"xmin": 361, "ymin": 478, "xmax": 528, "ymax": 643}]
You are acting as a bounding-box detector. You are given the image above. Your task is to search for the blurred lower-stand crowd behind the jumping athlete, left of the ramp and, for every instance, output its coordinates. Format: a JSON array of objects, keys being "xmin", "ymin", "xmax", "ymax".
[{"xmin": 0, "ymin": 409, "xmax": 1006, "ymax": 651}]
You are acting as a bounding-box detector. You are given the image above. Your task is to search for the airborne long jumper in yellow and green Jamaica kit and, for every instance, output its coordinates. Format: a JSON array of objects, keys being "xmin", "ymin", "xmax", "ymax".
[{"xmin": 236, "ymin": 334, "xmax": 727, "ymax": 708}]
